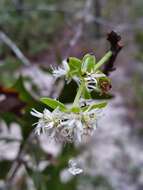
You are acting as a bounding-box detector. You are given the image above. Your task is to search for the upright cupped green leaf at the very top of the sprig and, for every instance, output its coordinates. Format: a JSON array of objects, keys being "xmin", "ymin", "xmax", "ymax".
[{"xmin": 81, "ymin": 54, "xmax": 96, "ymax": 73}]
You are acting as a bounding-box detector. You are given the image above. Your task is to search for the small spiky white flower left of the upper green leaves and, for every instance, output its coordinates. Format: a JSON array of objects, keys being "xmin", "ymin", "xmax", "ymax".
[{"xmin": 53, "ymin": 60, "xmax": 70, "ymax": 78}]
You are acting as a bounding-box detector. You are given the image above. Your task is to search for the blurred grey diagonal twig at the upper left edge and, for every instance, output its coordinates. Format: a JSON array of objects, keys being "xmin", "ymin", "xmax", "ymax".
[{"xmin": 0, "ymin": 31, "xmax": 30, "ymax": 66}]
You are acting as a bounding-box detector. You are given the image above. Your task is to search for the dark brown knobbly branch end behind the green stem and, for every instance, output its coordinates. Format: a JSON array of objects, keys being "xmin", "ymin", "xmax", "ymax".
[{"xmin": 103, "ymin": 31, "xmax": 123, "ymax": 75}]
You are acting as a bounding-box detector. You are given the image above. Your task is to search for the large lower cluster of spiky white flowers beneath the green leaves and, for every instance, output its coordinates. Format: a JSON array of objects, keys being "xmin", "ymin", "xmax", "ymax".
[{"xmin": 31, "ymin": 109, "xmax": 97, "ymax": 142}]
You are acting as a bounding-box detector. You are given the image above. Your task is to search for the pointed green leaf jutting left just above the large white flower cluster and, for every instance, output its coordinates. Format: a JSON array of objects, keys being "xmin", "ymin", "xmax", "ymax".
[{"xmin": 40, "ymin": 98, "xmax": 67, "ymax": 111}]
